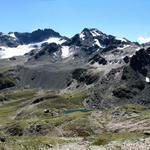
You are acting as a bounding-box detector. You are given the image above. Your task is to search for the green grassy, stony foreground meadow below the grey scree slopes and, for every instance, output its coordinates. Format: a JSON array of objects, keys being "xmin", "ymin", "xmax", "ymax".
[{"xmin": 0, "ymin": 89, "xmax": 150, "ymax": 150}]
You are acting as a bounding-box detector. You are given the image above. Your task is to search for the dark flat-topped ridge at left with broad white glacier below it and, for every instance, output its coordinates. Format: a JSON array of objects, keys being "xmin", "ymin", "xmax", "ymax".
[{"xmin": 0, "ymin": 29, "xmax": 66, "ymax": 58}]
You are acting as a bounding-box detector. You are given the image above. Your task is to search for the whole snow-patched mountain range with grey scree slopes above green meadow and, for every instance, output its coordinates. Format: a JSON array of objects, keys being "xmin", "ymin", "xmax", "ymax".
[{"xmin": 0, "ymin": 28, "xmax": 150, "ymax": 108}]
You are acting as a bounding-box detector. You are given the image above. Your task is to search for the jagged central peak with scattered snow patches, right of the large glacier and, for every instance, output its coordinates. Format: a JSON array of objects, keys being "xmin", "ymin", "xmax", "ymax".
[{"xmin": 24, "ymin": 28, "xmax": 141, "ymax": 68}]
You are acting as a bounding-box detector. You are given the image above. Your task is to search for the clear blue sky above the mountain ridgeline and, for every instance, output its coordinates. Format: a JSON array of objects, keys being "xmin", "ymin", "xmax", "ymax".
[{"xmin": 0, "ymin": 0, "xmax": 150, "ymax": 41}]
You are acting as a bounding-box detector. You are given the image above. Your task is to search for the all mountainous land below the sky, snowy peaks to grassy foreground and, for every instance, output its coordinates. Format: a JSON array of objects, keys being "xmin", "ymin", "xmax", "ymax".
[{"xmin": 0, "ymin": 28, "xmax": 150, "ymax": 150}]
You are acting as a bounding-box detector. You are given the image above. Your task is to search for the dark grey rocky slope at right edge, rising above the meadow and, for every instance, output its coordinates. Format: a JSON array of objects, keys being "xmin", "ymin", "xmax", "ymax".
[{"xmin": 93, "ymin": 49, "xmax": 150, "ymax": 108}]
